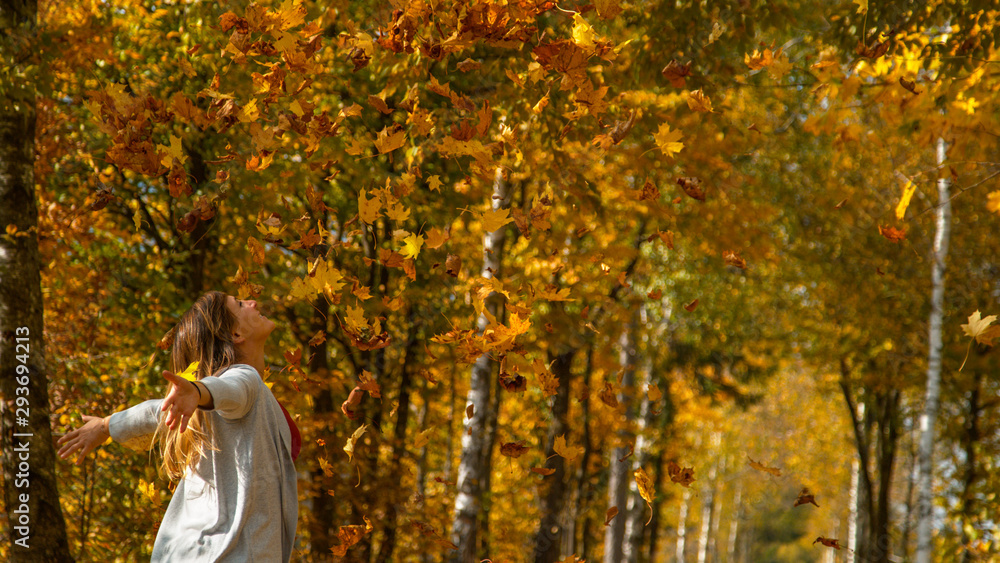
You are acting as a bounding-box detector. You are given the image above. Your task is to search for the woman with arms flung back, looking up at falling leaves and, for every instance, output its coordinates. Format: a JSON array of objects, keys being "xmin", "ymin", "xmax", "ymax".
[{"xmin": 59, "ymin": 292, "xmax": 314, "ymax": 562}]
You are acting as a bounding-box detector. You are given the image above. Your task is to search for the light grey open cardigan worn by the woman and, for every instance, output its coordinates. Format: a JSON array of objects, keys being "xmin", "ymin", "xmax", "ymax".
[{"xmin": 108, "ymin": 364, "xmax": 298, "ymax": 563}]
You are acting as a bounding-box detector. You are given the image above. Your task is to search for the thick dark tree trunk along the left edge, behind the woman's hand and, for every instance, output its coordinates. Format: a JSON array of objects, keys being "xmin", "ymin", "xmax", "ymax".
[{"xmin": 0, "ymin": 0, "xmax": 73, "ymax": 562}]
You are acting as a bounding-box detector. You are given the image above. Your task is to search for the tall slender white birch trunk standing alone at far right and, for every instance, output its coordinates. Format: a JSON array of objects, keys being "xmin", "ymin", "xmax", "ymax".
[{"xmin": 915, "ymin": 138, "xmax": 951, "ymax": 563}]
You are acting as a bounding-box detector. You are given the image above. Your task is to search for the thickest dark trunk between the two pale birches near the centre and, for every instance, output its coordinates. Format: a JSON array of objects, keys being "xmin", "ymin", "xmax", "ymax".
[{"xmin": 535, "ymin": 348, "xmax": 577, "ymax": 563}]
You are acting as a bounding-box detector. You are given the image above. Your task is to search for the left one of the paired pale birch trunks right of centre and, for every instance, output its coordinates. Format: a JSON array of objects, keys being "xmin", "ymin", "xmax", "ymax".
[{"xmin": 604, "ymin": 319, "xmax": 636, "ymax": 561}]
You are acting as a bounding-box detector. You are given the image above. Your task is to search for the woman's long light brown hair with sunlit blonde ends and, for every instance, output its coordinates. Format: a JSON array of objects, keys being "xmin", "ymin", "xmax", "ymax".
[{"xmin": 156, "ymin": 291, "xmax": 236, "ymax": 481}]
